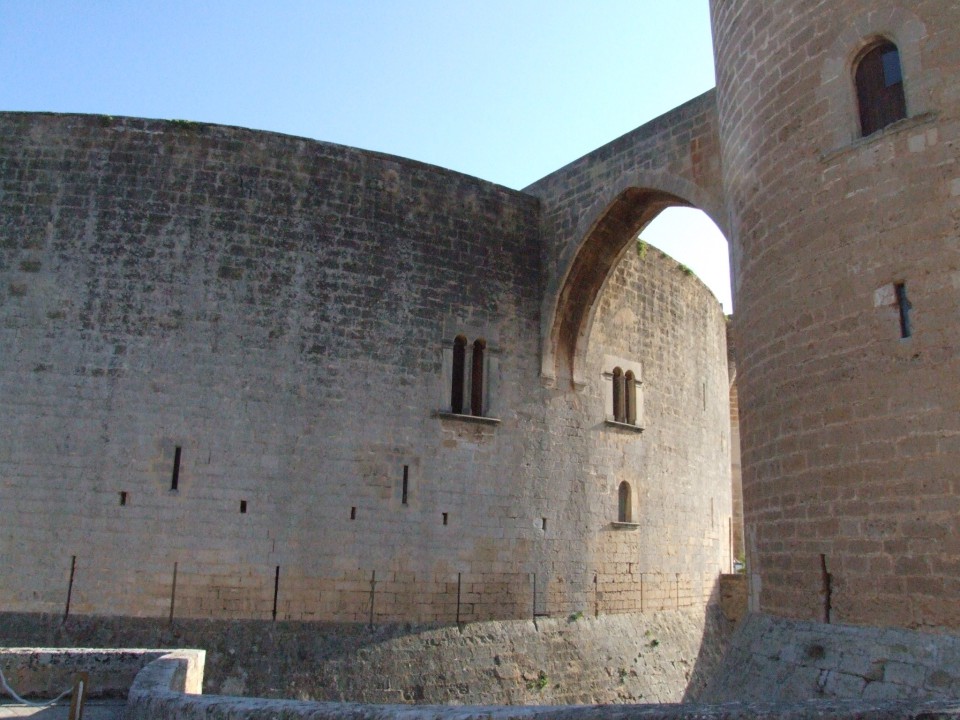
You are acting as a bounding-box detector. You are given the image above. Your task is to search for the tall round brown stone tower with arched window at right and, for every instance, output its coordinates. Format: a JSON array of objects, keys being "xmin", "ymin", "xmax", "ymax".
[{"xmin": 711, "ymin": 0, "xmax": 960, "ymax": 629}]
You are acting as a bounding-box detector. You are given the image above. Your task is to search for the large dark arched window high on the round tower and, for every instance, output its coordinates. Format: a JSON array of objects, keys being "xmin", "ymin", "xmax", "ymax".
[{"xmin": 855, "ymin": 40, "xmax": 907, "ymax": 137}]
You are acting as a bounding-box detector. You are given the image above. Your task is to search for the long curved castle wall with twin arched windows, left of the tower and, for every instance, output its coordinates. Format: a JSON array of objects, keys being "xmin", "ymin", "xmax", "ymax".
[{"xmin": 0, "ymin": 113, "xmax": 729, "ymax": 623}]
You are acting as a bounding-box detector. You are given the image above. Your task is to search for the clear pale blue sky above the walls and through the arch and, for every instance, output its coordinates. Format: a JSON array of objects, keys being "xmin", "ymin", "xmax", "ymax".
[{"xmin": 0, "ymin": 0, "xmax": 729, "ymax": 310}]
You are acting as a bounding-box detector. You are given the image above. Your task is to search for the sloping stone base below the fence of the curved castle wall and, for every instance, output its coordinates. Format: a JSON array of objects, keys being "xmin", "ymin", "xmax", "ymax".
[{"xmin": 0, "ymin": 608, "xmax": 732, "ymax": 705}]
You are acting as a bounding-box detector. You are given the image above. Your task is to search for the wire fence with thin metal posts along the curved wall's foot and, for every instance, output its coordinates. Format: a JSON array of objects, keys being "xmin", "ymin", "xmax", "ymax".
[{"xmin": 50, "ymin": 557, "xmax": 717, "ymax": 625}]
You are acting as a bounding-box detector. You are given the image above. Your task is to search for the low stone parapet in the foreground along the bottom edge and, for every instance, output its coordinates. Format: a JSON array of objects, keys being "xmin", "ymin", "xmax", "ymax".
[{"xmin": 0, "ymin": 648, "xmax": 960, "ymax": 720}]
